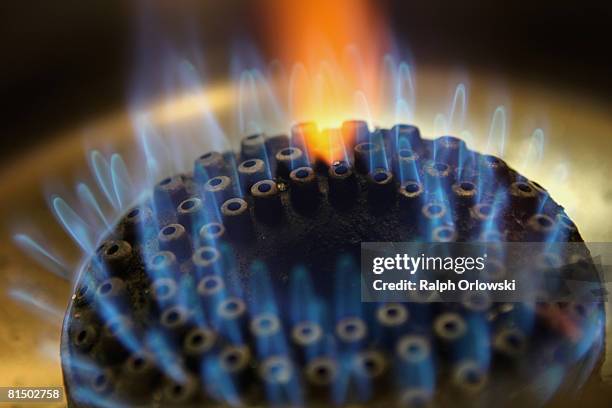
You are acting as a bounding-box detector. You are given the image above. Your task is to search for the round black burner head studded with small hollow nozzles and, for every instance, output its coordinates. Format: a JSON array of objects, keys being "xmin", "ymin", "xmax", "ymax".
[{"xmin": 62, "ymin": 121, "xmax": 588, "ymax": 406}]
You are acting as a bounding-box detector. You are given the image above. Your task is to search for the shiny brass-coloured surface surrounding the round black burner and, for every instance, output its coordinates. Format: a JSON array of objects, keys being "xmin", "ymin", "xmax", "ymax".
[{"xmin": 0, "ymin": 67, "xmax": 612, "ymax": 406}]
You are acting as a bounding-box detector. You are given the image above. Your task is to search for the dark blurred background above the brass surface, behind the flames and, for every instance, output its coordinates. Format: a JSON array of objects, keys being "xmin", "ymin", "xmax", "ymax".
[{"xmin": 0, "ymin": 0, "xmax": 612, "ymax": 155}]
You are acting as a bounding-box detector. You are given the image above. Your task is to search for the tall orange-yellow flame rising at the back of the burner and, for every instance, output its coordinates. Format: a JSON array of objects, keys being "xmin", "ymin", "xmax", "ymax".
[{"xmin": 262, "ymin": 0, "xmax": 390, "ymax": 163}]
